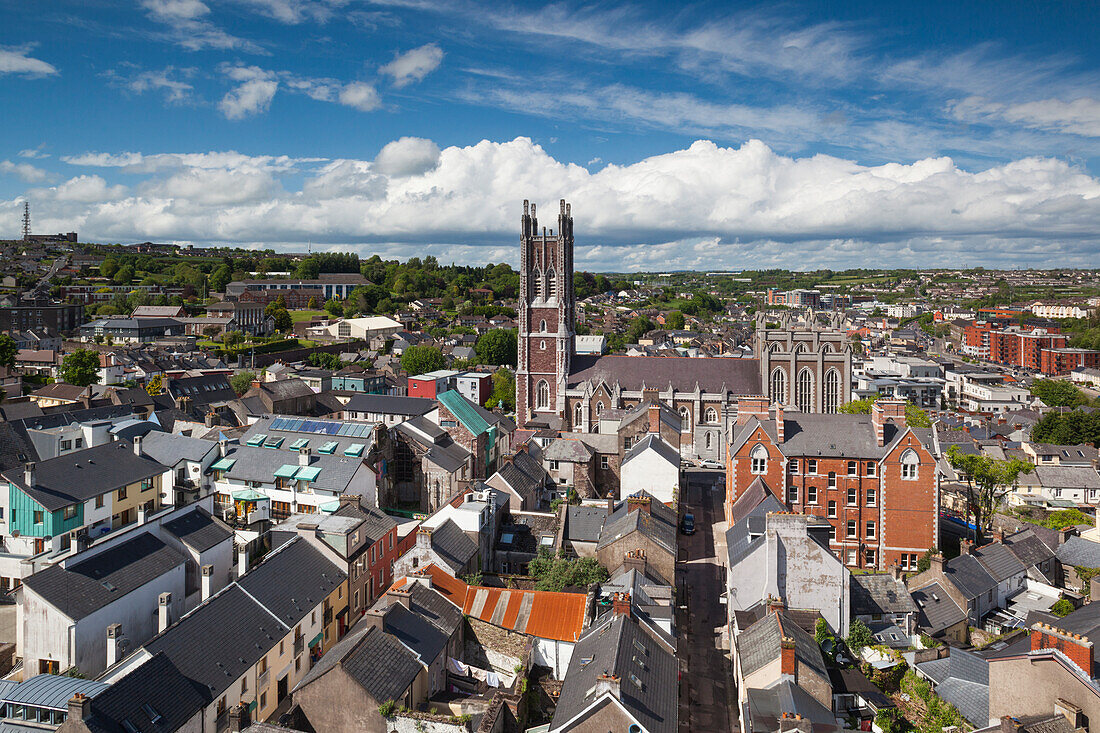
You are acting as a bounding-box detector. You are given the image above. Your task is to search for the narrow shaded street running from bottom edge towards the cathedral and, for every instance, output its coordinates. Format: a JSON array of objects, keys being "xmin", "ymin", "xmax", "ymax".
[{"xmin": 677, "ymin": 470, "xmax": 738, "ymax": 732}]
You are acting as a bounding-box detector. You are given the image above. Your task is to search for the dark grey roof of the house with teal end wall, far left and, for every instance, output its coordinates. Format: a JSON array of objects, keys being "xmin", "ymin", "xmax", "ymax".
[{"xmin": 3, "ymin": 440, "xmax": 165, "ymax": 512}]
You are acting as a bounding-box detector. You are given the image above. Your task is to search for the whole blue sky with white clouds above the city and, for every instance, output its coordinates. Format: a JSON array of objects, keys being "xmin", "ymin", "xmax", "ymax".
[{"xmin": 0, "ymin": 0, "xmax": 1100, "ymax": 272}]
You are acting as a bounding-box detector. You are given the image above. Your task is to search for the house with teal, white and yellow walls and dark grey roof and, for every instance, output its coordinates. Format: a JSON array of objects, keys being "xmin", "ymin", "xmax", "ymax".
[{"xmin": 0, "ymin": 438, "xmax": 165, "ymax": 588}]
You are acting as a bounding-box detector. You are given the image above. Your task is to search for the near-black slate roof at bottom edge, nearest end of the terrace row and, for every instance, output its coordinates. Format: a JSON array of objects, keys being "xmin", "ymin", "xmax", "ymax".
[{"xmin": 86, "ymin": 654, "xmax": 206, "ymax": 733}]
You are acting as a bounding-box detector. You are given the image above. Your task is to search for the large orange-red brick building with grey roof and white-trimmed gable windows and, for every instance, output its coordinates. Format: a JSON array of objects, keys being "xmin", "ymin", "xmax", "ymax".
[{"xmin": 726, "ymin": 397, "xmax": 939, "ymax": 570}]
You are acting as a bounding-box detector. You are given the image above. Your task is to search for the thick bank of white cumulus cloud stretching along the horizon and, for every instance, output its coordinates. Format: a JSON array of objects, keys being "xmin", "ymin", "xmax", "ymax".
[{"xmin": 0, "ymin": 138, "xmax": 1100, "ymax": 270}]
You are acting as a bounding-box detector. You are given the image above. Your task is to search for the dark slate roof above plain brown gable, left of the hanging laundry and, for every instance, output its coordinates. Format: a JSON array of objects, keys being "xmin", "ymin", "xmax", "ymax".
[{"xmin": 295, "ymin": 621, "xmax": 424, "ymax": 703}]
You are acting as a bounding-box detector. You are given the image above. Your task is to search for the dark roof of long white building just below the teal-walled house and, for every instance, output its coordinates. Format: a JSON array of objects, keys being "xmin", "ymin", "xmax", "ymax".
[{"xmin": 23, "ymin": 532, "xmax": 186, "ymax": 621}]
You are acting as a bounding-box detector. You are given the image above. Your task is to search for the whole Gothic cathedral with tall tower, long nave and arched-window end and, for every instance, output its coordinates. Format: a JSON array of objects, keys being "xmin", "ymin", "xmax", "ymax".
[{"xmin": 516, "ymin": 199, "xmax": 851, "ymax": 460}]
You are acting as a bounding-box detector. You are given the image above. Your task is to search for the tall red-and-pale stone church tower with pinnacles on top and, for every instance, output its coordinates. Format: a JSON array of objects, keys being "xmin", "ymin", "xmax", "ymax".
[{"xmin": 516, "ymin": 199, "xmax": 574, "ymax": 427}]
